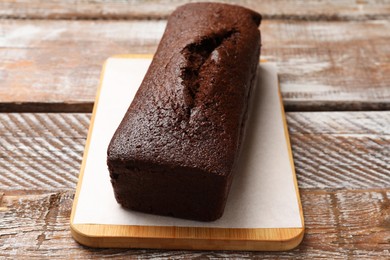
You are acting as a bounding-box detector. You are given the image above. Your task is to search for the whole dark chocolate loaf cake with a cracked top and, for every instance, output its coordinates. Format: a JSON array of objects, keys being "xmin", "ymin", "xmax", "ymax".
[{"xmin": 107, "ymin": 3, "xmax": 261, "ymax": 221}]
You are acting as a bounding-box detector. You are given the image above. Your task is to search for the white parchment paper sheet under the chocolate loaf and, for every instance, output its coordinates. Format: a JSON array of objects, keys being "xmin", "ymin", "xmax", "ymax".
[{"xmin": 73, "ymin": 58, "xmax": 302, "ymax": 228}]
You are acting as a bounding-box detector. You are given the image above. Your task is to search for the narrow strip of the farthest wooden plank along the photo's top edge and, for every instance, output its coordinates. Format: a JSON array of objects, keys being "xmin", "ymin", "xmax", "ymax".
[{"xmin": 0, "ymin": 0, "xmax": 390, "ymax": 21}]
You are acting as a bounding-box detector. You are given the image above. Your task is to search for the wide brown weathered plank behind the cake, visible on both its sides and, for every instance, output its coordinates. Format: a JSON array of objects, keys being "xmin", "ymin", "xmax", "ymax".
[{"xmin": 0, "ymin": 20, "xmax": 390, "ymax": 112}]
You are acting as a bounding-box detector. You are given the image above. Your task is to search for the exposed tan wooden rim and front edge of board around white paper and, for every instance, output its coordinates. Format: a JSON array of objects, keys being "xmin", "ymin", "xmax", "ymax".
[{"xmin": 71, "ymin": 55, "xmax": 304, "ymax": 251}]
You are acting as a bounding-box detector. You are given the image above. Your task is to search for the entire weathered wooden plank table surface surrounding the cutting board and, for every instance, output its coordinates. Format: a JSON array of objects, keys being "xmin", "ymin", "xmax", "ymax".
[{"xmin": 0, "ymin": 0, "xmax": 390, "ymax": 259}]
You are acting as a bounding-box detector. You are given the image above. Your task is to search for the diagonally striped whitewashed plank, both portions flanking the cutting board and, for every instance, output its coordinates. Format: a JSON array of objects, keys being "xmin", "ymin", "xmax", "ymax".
[{"xmin": 0, "ymin": 112, "xmax": 390, "ymax": 191}]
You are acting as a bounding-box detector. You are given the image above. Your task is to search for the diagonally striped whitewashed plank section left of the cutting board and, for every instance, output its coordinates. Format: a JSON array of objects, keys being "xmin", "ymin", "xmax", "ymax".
[{"xmin": 0, "ymin": 114, "xmax": 89, "ymax": 190}]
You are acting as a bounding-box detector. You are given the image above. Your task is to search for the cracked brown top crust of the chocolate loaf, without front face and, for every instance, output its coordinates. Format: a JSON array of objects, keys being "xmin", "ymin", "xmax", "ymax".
[{"xmin": 108, "ymin": 3, "xmax": 261, "ymax": 175}]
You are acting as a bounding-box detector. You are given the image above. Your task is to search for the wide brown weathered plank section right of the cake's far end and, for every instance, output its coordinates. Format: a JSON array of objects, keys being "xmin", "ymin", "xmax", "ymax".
[{"xmin": 262, "ymin": 21, "xmax": 390, "ymax": 111}]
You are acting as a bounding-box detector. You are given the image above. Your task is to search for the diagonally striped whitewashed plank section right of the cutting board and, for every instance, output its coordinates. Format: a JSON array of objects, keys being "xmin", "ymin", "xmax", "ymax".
[{"xmin": 287, "ymin": 112, "xmax": 390, "ymax": 189}]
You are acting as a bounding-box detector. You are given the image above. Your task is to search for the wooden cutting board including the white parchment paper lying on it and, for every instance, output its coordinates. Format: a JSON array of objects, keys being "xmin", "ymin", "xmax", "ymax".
[{"xmin": 70, "ymin": 55, "xmax": 304, "ymax": 251}]
